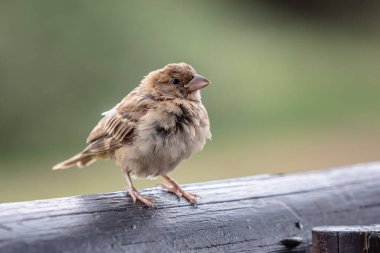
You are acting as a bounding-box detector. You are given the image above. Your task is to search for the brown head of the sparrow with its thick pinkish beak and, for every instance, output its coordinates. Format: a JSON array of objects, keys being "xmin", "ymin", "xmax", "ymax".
[{"xmin": 142, "ymin": 63, "xmax": 210, "ymax": 99}]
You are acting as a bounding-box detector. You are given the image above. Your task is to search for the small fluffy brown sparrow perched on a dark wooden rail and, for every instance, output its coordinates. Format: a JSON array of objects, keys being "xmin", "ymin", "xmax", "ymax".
[{"xmin": 53, "ymin": 63, "xmax": 211, "ymax": 206}]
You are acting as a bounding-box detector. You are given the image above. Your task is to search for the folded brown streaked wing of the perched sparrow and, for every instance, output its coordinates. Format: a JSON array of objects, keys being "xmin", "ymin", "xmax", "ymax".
[{"xmin": 83, "ymin": 92, "xmax": 154, "ymax": 155}]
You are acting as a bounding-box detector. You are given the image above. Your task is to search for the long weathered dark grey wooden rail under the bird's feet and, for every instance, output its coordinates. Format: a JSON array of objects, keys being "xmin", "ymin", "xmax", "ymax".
[{"xmin": 0, "ymin": 163, "xmax": 380, "ymax": 253}]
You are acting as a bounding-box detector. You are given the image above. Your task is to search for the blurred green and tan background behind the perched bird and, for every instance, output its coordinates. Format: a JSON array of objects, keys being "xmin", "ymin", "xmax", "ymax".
[{"xmin": 0, "ymin": 0, "xmax": 380, "ymax": 202}]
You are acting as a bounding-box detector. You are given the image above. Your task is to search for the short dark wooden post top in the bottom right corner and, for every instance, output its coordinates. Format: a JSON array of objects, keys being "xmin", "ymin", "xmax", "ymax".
[{"xmin": 312, "ymin": 225, "xmax": 380, "ymax": 253}]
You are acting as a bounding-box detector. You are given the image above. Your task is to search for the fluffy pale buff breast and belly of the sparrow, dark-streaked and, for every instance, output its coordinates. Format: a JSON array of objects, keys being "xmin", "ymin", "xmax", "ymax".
[{"xmin": 126, "ymin": 103, "xmax": 211, "ymax": 177}]
